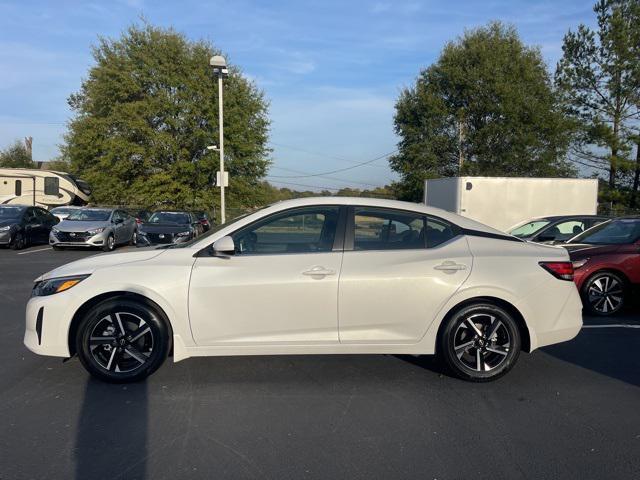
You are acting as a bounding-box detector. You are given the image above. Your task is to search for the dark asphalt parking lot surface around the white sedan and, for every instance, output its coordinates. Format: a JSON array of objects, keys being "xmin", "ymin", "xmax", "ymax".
[{"xmin": 0, "ymin": 246, "xmax": 640, "ymax": 480}]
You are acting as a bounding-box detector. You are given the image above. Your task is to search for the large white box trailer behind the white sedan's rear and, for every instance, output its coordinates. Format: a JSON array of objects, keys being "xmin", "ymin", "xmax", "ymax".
[{"xmin": 424, "ymin": 177, "xmax": 598, "ymax": 231}]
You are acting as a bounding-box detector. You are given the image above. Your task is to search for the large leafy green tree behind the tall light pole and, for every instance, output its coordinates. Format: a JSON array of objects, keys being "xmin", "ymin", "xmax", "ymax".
[{"xmin": 62, "ymin": 23, "xmax": 269, "ymax": 210}]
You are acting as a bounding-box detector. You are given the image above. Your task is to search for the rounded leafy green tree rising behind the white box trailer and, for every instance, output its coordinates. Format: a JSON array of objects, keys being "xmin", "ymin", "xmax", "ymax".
[{"xmin": 390, "ymin": 22, "xmax": 573, "ymax": 200}]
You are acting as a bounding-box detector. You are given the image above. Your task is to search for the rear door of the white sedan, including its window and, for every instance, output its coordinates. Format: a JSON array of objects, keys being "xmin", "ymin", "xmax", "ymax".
[{"xmin": 338, "ymin": 207, "xmax": 472, "ymax": 343}]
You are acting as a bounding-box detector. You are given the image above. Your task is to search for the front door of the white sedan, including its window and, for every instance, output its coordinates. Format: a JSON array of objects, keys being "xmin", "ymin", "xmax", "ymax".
[{"xmin": 189, "ymin": 205, "xmax": 345, "ymax": 345}]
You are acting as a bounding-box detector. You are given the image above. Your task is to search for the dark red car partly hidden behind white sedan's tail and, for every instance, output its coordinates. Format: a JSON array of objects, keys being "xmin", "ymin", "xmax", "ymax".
[{"xmin": 563, "ymin": 217, "xmax": 640, "ymax": 315}]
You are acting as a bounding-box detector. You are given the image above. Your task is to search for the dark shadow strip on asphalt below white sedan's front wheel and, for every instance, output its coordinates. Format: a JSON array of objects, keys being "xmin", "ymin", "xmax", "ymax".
[{"xmin": 74, "ymin": 378, "xmax": 149, "ymax": 480}]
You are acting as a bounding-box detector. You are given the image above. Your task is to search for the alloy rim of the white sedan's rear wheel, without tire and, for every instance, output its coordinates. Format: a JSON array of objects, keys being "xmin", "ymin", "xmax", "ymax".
[{"xmin": 453, "ymin": 313, "xmax": 511, "ymax": 372}]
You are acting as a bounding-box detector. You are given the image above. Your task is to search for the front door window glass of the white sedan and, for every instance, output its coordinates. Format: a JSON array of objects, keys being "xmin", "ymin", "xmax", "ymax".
[{"xmin": 233, "ymin": 206, "xmax": 340, "ymax": 254}]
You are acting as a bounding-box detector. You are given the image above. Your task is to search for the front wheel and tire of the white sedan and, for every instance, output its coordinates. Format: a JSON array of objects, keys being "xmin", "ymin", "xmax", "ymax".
[{"xmin": 75, "ymin": 298, "xmax": 171, "ymax": 383}]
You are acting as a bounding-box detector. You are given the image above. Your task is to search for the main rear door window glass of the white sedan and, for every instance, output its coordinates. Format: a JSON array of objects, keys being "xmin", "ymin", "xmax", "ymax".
[{"xmin": 353, "ymin": 207, "xmax": 425, "ymax": 250}]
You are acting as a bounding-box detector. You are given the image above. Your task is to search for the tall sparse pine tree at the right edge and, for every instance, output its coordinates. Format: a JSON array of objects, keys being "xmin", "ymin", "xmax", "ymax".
[{"xmin": 555, "ymin": 0, "xmax": 640, "ymax": 202}]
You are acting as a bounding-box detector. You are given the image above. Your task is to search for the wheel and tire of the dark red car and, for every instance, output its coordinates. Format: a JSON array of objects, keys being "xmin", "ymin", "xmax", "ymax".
[{"xmin": 580, "ymin": 271, "xmax": 629, "ymax": 317}]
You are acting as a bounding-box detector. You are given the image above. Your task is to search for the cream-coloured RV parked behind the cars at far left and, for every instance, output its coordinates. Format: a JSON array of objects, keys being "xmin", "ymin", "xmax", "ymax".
[{"xmin": 0, "ymin": 168, "xmax": 91, "ymax": 209}]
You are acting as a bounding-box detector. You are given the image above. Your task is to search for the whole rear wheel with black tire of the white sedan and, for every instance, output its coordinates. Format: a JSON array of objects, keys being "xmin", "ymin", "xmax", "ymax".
[{"xmin": 438, "ymin": 302, "xmax": 522, "ymax": 382}]
